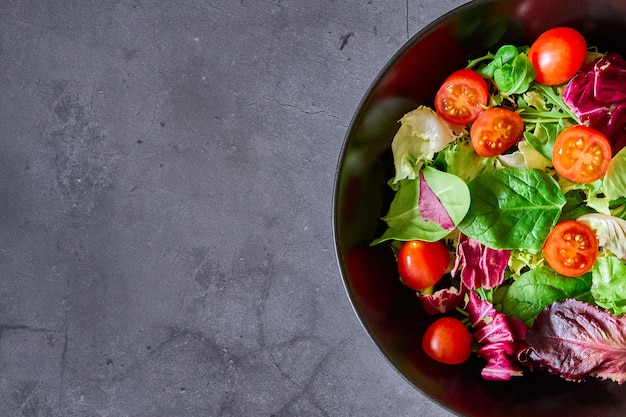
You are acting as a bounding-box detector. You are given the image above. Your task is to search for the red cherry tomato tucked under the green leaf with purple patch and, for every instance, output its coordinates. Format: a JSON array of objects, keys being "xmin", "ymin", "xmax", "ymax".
[{"xmin": 398, "ymin": 240, "xmax": 450, "ymax": 291}]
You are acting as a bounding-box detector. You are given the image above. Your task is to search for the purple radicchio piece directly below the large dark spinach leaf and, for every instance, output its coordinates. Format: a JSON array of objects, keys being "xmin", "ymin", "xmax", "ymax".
[{"xmin": 452, "ymin": 234, "xmax": 511, "ymax": 289}]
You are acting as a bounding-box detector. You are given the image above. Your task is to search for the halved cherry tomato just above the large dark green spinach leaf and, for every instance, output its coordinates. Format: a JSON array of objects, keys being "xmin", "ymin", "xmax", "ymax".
[{"xmin": 470, "ymin": 107, "xmax": 524, "ymax": 157}]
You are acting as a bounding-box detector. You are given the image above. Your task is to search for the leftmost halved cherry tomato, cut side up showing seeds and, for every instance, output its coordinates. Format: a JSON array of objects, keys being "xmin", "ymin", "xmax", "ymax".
[{"xmin": 435, "ymin": 69, "xmax": 489, "ymax": 126}]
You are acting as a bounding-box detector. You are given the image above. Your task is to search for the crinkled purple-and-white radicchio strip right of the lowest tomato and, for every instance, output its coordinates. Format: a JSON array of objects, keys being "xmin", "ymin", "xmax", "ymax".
[{"xmin": 467, "ymin": 290, "xmax": 527, "ymax": 381}]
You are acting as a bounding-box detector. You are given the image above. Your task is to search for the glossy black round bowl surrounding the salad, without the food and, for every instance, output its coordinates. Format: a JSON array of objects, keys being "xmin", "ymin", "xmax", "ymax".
[{"xmin": 334, "ymin": 0, "xmax": 626, "ymax": 417}]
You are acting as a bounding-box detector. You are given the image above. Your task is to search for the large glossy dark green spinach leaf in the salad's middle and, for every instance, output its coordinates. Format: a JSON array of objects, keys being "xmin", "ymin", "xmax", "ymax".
[{"xmin": 459, "ymin": 168, "xmax": 566, "ymax": 251}]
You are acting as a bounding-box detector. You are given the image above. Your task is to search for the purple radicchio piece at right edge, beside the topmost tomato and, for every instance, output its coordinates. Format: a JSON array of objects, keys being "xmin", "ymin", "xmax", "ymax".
[{"xmin": 563, "ymin": 53, "xmax": 626, "ymax": 154}]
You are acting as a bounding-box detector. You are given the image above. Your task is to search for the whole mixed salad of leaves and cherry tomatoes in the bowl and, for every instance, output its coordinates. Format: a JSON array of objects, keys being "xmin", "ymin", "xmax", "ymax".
[{"xmin": 372, "ymin": 28, "xmax": 626, "ymax": 383}]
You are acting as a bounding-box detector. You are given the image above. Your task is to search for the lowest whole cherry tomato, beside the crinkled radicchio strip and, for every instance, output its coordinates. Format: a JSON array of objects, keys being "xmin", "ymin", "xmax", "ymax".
[{"xmin": 422, "ymin": 317, "xmax": 472, "ymax": 365}]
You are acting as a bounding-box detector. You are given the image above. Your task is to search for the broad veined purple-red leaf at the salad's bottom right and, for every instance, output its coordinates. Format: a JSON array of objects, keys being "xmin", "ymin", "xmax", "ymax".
[{"xmin": 527, "ymin": 299, "xmax": 626, "ymax": 384}]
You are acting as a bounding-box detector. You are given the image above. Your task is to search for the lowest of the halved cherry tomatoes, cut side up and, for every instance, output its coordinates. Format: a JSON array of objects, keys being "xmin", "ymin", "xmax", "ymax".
[{"xmin": 543, "ymin": 220, "xmax": 598, "ymax": 277}]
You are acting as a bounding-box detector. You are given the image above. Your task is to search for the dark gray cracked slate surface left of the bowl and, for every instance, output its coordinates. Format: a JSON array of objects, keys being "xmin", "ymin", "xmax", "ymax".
[{"xmin": 0, "ymin": 0, "xmax": 464, "ymax": 417}]
